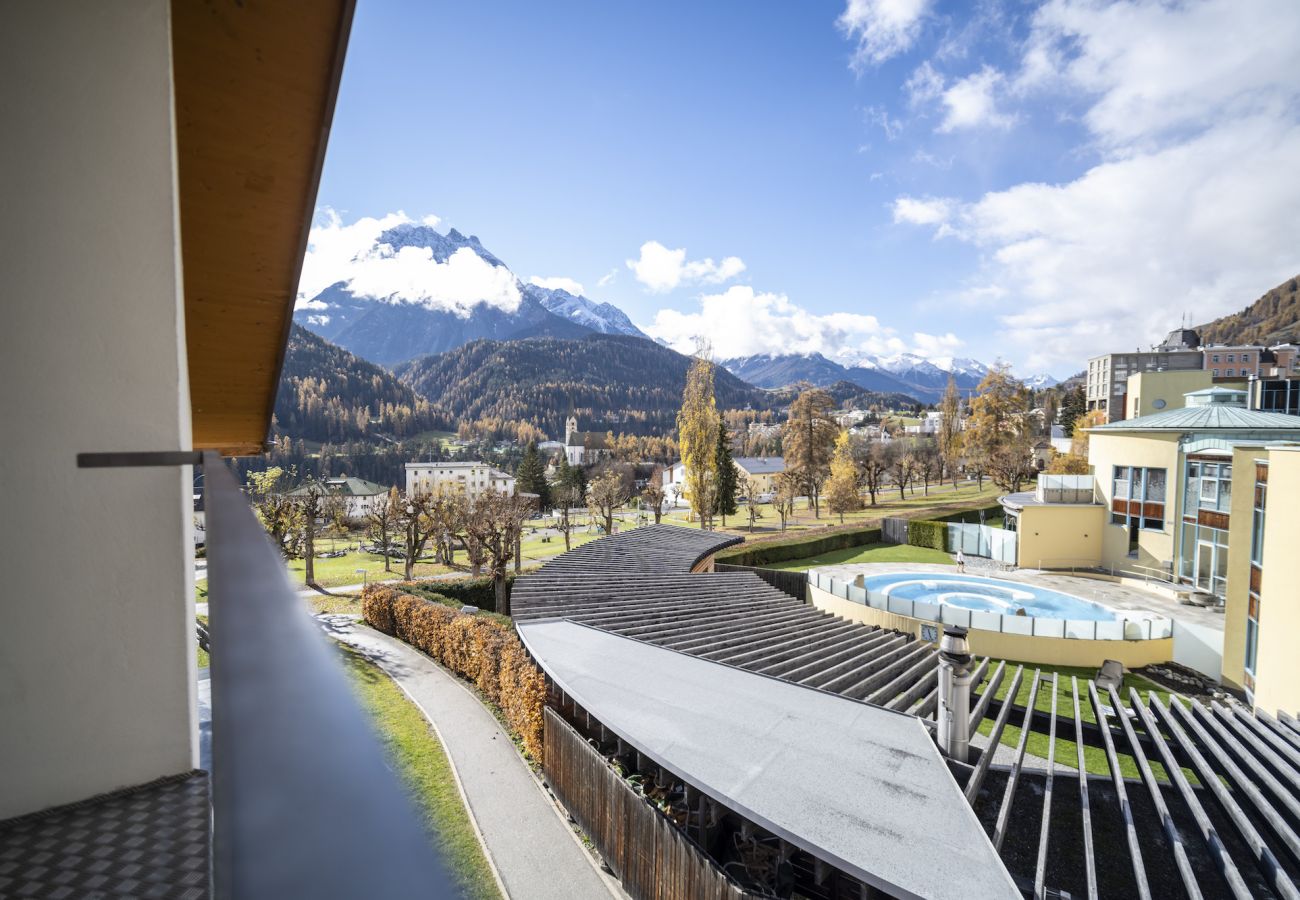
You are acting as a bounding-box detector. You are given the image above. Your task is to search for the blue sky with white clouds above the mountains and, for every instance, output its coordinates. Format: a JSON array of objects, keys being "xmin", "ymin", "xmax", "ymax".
[{"xmin": 309, "ymin": 0, "xmax": 1300, "ymax": 376}]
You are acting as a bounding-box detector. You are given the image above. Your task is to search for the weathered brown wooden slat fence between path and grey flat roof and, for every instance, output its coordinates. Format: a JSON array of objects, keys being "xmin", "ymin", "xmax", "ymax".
[{"xmin": 545, "ymin": 708, "xmax": 758, "ymax": 900}]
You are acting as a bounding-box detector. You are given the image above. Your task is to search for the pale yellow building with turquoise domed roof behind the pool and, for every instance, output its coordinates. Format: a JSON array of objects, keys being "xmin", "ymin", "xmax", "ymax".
[{"xmin": 1002, "ymin": 387, "xmax": 1300, "ymax": 710}]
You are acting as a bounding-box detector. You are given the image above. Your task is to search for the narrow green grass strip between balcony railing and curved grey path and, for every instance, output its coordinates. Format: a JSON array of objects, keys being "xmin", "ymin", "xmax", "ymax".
[{"xmin": 341, "ymin": 646, "xmax": 501, "ymax": 899}]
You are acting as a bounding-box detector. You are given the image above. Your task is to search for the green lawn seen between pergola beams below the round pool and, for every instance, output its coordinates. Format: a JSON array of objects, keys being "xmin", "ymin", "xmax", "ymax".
[{"xmin": 979, "ymin": 659, "xmax": 1196, "ymax": 784}]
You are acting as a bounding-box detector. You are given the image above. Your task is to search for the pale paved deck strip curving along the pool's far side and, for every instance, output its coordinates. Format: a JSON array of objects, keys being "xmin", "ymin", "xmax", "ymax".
[{"xmin": 810, "ymin": 558, "xmax": 1223, "ymax": 631}]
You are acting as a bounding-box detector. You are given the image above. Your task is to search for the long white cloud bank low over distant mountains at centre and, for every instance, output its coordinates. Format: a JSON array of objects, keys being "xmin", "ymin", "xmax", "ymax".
[{"xmin": 642, "ymin": 285, "xmax": 905, "ymax": 359}]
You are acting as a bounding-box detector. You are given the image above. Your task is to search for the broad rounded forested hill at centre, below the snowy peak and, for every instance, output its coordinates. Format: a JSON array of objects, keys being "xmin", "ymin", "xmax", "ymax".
[{"xmin": 397, "ymin": 334, "xmax": 779, "ymax": 437}]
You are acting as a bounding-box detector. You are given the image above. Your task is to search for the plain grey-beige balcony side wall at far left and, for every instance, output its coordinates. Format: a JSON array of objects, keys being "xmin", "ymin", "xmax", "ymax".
[{"xmin": 0, "ymin": 0, "xmax": 198, "ymax": 818}]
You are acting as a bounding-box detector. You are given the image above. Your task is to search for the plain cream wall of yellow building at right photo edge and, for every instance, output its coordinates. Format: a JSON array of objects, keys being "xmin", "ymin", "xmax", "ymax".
[{"xmin": 1234, "ymin": 446, "xmax": 1300, "ymax": 715}]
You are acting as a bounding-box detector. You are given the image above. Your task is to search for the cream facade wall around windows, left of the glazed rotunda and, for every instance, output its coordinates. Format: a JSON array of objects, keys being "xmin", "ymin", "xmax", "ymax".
[{"xmin": 1088, "ymin": 432, "xmax": 1180, "ymax": 568}]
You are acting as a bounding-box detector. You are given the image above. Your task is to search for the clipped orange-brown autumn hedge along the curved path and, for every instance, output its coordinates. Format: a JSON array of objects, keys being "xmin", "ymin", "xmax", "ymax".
[{"xmin": 361, "ymin": 584, "xmax": 546, "ymax": 761}]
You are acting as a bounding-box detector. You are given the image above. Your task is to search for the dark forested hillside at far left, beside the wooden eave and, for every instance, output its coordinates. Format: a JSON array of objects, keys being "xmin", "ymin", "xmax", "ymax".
[{"xmin": 276, "ymin": 325, "xmax": 446, "ymax": 443}]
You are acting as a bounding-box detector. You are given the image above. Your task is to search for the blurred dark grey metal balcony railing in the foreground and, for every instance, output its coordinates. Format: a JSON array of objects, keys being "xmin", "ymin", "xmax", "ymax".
[{"xmin": 203, "ymin": 454, "xmax": 456, "ymax": 900}]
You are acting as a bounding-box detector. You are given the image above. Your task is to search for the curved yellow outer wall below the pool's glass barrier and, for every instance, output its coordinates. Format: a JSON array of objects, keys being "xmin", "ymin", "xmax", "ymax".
[{"xmin": 809, "ymin": 585, "xmax": 1174, "ymax": 668}]
